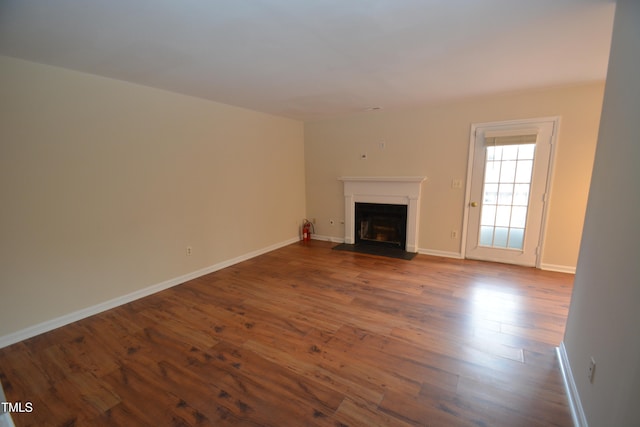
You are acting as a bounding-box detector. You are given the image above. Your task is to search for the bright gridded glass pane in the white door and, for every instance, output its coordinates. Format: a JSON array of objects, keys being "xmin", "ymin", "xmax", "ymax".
[{"xmin": 478, "ymin": 144, "xmax": 535, "ymax": 250}]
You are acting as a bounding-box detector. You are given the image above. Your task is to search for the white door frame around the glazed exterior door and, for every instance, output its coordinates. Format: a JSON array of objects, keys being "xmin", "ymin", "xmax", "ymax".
[{"xmin": 460, "ymin": 116, "xmax": 560, "ymax": 268}]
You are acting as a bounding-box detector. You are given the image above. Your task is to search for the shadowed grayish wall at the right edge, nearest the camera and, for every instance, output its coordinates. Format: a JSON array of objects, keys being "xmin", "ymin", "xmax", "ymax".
[{"xmin": 564, "ymin": 0, "xmax": 640, "ymax": 427}]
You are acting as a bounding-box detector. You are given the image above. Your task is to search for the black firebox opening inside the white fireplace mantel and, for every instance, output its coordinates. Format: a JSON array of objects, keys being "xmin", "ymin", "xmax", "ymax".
[{"xmin": 354, "ymin": 203, "xmax": 407, "ymax": 250}]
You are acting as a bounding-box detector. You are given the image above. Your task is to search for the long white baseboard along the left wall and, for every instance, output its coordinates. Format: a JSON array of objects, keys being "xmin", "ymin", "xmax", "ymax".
[{"xmin": 0, "ymin": 237, "xmax": 300, "ymax": 348}]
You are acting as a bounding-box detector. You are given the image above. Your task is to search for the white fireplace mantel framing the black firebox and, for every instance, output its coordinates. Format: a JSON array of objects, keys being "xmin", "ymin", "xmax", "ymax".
[{"xmin": 338, "ymin": 176, "xmax": 427, "ymax": 252}]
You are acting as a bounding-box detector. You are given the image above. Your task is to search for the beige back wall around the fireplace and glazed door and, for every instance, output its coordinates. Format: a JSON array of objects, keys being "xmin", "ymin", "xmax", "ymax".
[{"xmin": 305, "ymin": 82, "xmax": 604, "ymax": 268}]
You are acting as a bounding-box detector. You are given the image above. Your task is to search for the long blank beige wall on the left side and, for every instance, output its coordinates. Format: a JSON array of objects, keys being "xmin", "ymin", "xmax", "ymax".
[{"xmin": 0, "ymin": 57, "xmax": 305, "ymax": 338}]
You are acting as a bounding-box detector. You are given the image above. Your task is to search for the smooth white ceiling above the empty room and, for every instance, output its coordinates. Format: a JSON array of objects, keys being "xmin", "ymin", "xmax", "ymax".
[{"xmin": 0, "ymin": 0, "xmax": 615, "ymax": 120}]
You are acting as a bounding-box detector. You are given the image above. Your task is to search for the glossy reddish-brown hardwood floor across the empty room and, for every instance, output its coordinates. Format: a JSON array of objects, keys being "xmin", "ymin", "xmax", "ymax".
[{"xmin": 0, "ymin": 241, "xmax": 573, "ymax": 427}]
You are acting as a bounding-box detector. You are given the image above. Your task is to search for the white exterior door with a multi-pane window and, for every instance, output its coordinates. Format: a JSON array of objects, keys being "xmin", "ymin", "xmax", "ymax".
[{"xmin": 465, "ymin": 118, "xmax": 557, "ymax": 266}]
